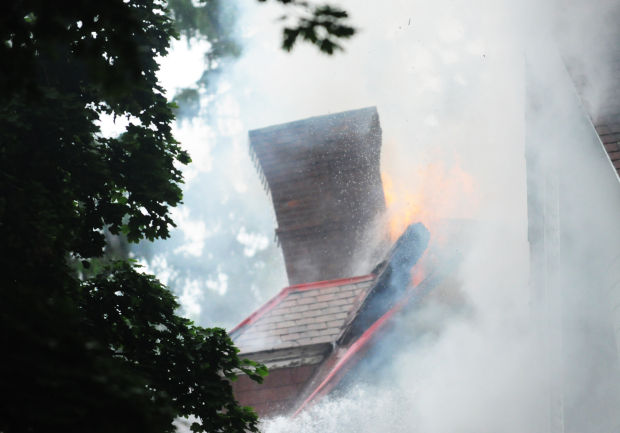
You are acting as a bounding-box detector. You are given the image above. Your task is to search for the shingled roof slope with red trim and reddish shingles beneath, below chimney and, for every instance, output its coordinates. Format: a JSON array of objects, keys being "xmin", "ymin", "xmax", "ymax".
[{"xmin": 230, "ymin": 275, "xmax": 375, "ymax": 415}]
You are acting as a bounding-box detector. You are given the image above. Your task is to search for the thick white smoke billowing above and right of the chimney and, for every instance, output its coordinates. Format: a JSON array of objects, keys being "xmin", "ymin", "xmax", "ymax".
[{"xmin": 211, "ymin": 0, "xmax": 620, "ymax": 433}]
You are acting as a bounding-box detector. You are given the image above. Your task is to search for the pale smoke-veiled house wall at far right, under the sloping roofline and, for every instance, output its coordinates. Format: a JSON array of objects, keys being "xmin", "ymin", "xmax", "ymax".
[{"xmin": 526, "ymin": 45, "xmax": 620, "ymax": 433}]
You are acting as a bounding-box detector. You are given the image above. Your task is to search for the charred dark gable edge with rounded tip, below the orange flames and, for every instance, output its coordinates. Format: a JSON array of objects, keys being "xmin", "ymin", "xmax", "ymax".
[{"xmin": 340, "ymin": 223, "xmax": 430, "ymax": 345}]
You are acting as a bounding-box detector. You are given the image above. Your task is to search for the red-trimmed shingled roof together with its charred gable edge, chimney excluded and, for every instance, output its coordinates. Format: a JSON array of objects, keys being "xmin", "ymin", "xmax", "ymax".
[{"xmin": 231, "ymin": 224, "xmax": 440, "ymax": 415}]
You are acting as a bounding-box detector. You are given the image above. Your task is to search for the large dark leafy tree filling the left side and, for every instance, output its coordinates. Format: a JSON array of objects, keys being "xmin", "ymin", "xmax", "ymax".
[{"xmin": 0, "ymin": 0, "xmax": 265, "ymax": 433}]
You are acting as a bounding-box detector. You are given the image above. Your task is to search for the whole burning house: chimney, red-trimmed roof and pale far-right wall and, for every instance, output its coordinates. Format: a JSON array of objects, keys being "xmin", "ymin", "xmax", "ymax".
[{"xmin": 230, "ymin": 40, "xmax": 620, "ymax": 426}]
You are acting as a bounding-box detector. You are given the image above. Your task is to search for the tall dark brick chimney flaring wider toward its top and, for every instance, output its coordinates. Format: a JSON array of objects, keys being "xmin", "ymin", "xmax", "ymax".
[{"xmin": 250, "ymin": 107, "xmax": 385, "ymax": 284}]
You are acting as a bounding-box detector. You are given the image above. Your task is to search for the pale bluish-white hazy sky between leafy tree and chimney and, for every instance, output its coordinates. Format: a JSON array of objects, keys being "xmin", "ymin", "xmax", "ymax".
[{"xmin": 102, "ymin": 3, "xmax": 287, "ymax": 329}]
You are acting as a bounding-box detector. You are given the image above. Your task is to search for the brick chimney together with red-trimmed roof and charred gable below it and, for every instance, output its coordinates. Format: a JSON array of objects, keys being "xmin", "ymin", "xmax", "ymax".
[{"xmin": 230, "ymin": 107, "xmax": 460, "ymax": 416}]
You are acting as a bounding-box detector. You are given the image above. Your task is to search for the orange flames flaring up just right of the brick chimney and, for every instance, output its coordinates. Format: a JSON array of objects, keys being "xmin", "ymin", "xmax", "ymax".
[{"xmin": 381, "ymin": 163, "xmax": 477, "ymax": 240}]
